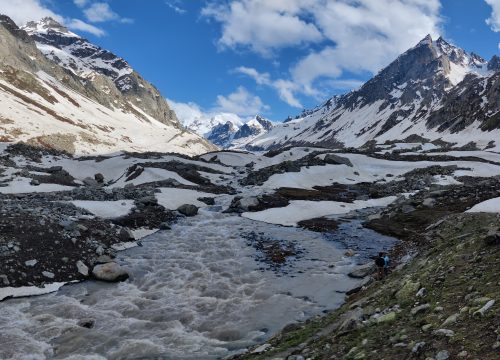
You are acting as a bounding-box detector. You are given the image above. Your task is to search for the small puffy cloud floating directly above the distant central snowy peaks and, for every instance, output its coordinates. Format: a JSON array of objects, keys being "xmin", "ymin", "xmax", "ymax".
[{"xmin": 214, "ymin": 86, "xmax": 269, "ymax": 116}]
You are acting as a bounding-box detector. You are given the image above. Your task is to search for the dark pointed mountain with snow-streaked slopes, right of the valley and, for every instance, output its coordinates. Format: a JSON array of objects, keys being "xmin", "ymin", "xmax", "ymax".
[{"xmin": 248, "ymin": 36, "xmax": 500, "ymax": 153}]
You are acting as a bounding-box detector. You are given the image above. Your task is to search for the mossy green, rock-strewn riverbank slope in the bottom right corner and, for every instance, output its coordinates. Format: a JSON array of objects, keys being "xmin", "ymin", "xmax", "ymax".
[{"xmin": 237, "ymin": 213, "xmax": 500, "ymax": 360}]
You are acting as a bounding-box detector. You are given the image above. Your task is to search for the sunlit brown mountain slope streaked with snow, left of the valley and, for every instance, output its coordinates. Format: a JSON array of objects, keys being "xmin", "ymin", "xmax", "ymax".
[{"xmin": 0, "ymin": 16, "xmax": 215, "ymax": 154}]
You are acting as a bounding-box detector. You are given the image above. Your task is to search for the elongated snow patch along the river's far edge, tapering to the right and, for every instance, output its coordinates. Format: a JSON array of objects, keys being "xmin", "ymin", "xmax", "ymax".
[{"xmin": 242, "ymin": 196, "xmax": 397, "ymax": 226}]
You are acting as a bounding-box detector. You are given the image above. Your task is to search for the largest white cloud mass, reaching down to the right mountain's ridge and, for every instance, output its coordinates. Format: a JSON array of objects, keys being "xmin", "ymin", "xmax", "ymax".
[{"xmin": 202, "ymin": 0, "xmax": 442, "ymax": 107}]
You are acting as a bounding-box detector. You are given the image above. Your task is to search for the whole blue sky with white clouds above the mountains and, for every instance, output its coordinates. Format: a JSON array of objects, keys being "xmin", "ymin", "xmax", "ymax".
[{"xmin": 0, "ymin": 0, "xmax": 500, "ymax": 126}]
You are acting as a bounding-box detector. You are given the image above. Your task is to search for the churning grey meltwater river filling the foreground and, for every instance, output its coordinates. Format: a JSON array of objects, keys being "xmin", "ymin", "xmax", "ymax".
[{"xmin": 0, "ymin": 198, "xmax": 393, "ymax": 360}]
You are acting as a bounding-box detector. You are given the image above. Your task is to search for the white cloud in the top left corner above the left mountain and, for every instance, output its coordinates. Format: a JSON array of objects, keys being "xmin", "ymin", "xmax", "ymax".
[{"xmin": 0, "ymin": 0, "xmax": 63, "ymax": 26}]
